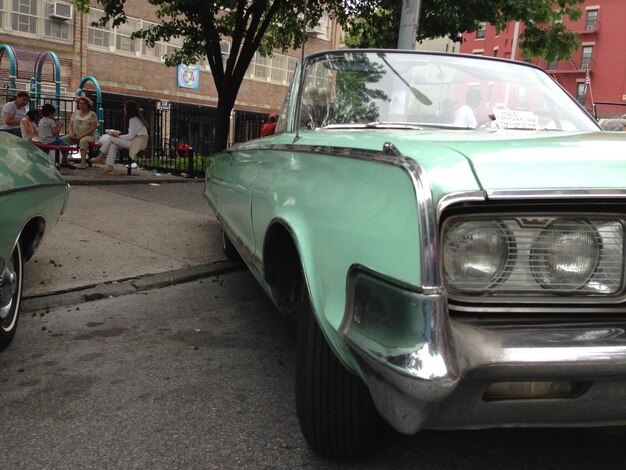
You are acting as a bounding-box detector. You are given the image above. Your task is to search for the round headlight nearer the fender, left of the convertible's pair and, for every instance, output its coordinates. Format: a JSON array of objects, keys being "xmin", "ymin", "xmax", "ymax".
[{"xmin": 443, "ymin": 220, "xmax": 512, "ymax": 290}]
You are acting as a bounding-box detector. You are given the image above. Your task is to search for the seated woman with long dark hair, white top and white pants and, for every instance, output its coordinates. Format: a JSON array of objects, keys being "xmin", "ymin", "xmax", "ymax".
[{"xmin": 96, "ymin": 101, "xmax": 148, "ymax": 175}]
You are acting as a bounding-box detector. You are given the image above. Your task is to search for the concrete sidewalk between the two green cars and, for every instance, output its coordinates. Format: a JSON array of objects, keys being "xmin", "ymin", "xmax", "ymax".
[{"xmin": 23, "ymin": 165, "xmax": 237, "ymax": 311}]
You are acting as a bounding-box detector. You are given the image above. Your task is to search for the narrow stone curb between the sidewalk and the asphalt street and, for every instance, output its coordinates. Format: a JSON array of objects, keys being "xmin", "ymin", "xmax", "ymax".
[{"xmin": 21, "ymin": 261, "xmax": 244, "ymax": 313}]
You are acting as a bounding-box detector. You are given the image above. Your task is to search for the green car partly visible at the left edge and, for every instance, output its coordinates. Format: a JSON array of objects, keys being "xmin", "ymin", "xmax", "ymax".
[{"xmin": 0, "ymin": 132, "xmax": 69, "ymax": 351}]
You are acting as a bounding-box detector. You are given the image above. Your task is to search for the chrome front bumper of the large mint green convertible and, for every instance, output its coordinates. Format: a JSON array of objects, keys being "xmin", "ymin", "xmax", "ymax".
[{"xmin": 339, "ymin": 273, "xmax": 626, "ymax": 434}]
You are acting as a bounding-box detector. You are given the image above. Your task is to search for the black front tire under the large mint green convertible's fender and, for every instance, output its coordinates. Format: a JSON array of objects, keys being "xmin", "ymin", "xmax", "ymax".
[{"xmin": 296, "ymin": 280, "xmax": 382, "ymax": 459}]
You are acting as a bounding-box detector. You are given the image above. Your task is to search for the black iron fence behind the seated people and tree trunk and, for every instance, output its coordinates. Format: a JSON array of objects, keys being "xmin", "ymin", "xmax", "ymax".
[{"xmin": 0, "ymin": 90, "xmax": 268, "ymax": 177}]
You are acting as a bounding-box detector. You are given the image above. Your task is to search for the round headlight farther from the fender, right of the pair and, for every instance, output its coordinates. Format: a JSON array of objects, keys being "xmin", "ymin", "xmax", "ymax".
[{"xmin": 530, "ymin": 219, "xmax": 600, "ymax": 291}]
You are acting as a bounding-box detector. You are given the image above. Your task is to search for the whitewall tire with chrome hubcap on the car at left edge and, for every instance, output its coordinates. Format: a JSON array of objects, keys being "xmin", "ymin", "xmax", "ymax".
[{"xmin": 0, "ymin": 243, "xmax": 24, "ymax": 351}]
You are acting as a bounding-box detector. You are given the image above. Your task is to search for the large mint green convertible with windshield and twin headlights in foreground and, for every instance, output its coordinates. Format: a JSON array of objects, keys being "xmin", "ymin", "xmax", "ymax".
[{"xmin": 205, "ymin": 50, "xmax": 626, "ymax": 457}]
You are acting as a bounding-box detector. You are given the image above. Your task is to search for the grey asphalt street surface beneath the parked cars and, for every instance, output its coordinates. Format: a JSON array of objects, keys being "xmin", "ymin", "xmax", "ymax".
[{"xmin": 0, "ymin": 270, "xmax": 626, "ymax": 470}]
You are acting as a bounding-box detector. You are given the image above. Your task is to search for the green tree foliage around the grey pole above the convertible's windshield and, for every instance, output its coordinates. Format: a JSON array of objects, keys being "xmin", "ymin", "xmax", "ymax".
[{"xmin": 346, "ymin": 0, "xmax": 583, "ymax": 61}]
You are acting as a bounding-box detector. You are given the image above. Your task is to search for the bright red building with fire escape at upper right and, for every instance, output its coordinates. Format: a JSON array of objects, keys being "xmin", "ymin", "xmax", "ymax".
[{"xmin": 460, "ymin": 0, "xmax": 626, "ymax": 117}]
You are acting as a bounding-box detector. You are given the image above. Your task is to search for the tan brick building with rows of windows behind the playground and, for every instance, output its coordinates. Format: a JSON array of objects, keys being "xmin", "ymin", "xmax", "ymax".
[{"xmin": 0, "ymin": 0, "xmax": 340, "ymax": 148}]
